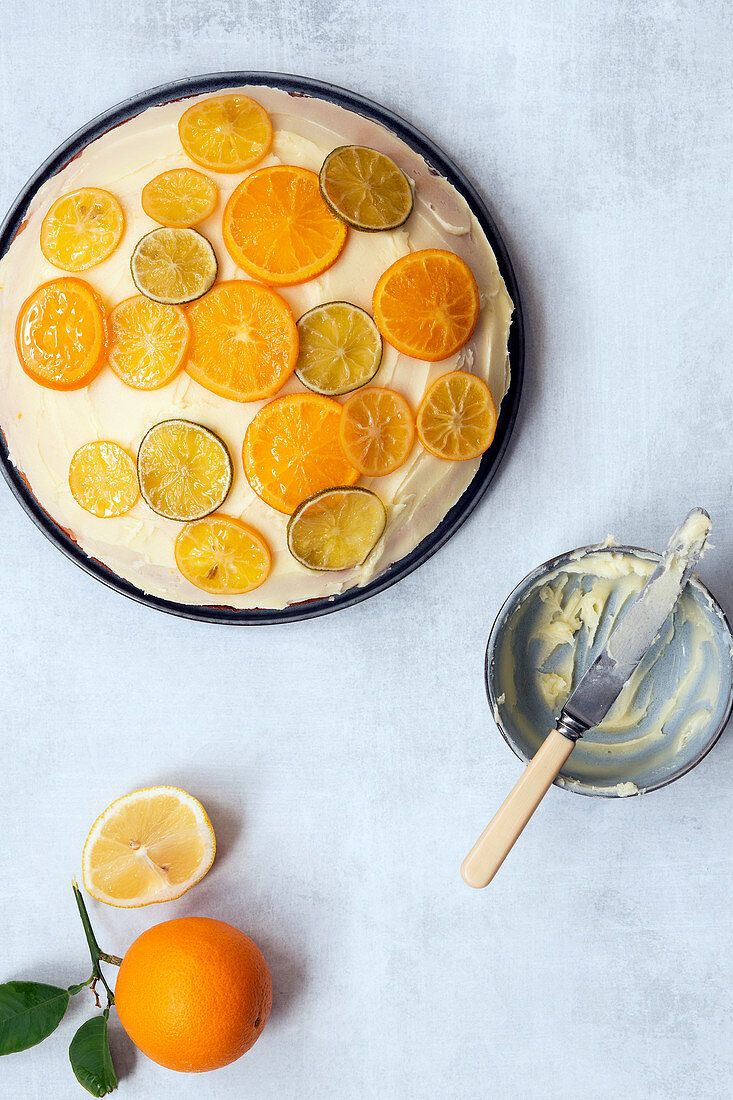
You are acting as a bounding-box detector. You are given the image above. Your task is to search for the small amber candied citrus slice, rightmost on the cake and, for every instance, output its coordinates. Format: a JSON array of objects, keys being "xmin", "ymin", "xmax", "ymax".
[{"xmin": 417, "ymin": 371, "xmax": 496, "ymax": 460}]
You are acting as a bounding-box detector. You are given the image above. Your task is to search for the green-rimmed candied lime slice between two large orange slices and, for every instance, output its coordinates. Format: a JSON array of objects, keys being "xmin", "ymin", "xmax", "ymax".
[{"xmin": 295, "ymin": 301, "xmax": 382, "ymax": 397}]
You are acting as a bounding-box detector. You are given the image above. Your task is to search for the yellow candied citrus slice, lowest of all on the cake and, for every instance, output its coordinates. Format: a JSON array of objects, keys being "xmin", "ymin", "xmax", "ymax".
[{"xmin": 175, "ymin": 515, "xmax": 272, "ymax": 596}]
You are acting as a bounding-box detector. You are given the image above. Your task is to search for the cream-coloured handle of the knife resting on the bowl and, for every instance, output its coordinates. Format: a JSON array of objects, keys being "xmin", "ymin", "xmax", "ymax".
[{"xmin": 461, "ymin": 729, "xmax": 576, "ymax": 890}]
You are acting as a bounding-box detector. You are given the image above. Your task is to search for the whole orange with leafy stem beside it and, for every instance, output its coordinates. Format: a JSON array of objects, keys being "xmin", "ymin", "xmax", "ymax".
[{"xmin": 114, "ymin": 916, "xmax": 272, "ymax": 1074}]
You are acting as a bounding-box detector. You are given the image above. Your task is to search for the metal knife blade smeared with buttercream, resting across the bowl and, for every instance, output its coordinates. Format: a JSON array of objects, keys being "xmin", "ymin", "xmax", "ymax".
[{"xmin": 557, "ymin": 508, "xmax": 711, "ymax": 740}]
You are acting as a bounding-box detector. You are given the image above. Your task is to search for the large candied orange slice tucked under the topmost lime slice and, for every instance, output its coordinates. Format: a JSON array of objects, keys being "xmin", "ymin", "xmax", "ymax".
[{"xmin": 222, "ymin": 164, "xmax": 348, "ymax": 286}]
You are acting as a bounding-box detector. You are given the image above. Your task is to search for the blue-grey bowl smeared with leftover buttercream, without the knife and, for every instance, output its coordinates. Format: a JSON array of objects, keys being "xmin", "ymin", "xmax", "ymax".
[{"xmin": 486, "ymin": 546, "xmax": 733, "ymax": 796}]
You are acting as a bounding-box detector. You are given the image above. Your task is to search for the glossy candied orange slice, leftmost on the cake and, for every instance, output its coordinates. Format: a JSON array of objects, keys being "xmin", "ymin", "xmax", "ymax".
[{"xmin": 15, "ymin": 277, "xmax": 107, "ymax": 389}]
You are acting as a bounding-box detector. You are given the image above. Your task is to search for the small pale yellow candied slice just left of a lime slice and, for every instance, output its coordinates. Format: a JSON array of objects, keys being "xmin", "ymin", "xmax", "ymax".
[{"xmin": 68, "ymin": 439, "xmax": 140, "ymax": 519}]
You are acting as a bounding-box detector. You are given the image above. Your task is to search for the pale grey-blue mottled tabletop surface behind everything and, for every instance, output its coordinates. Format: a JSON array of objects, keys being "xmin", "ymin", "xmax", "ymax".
[{"xmin": 0, "ymin": 0, "xmax": 733, "ymax": 1100}]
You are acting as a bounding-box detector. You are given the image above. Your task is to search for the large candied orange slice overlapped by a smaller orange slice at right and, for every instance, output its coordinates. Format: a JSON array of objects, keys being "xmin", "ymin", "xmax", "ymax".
[{"xmin": 242, "ymin": 394, "xmax": 359, "ymax": 514}]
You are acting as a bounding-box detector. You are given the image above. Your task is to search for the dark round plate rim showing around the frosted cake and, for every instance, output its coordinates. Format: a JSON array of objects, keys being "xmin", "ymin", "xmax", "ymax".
[{"xmin": 0, "ymin": 72, "xmax": 525, "ymax": 625}]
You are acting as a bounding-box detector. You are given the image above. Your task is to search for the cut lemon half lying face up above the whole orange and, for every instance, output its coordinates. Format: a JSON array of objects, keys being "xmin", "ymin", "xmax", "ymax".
[{"xmin": 81, "ymin": 787, "xmax": 216, "ymax": 909}]
